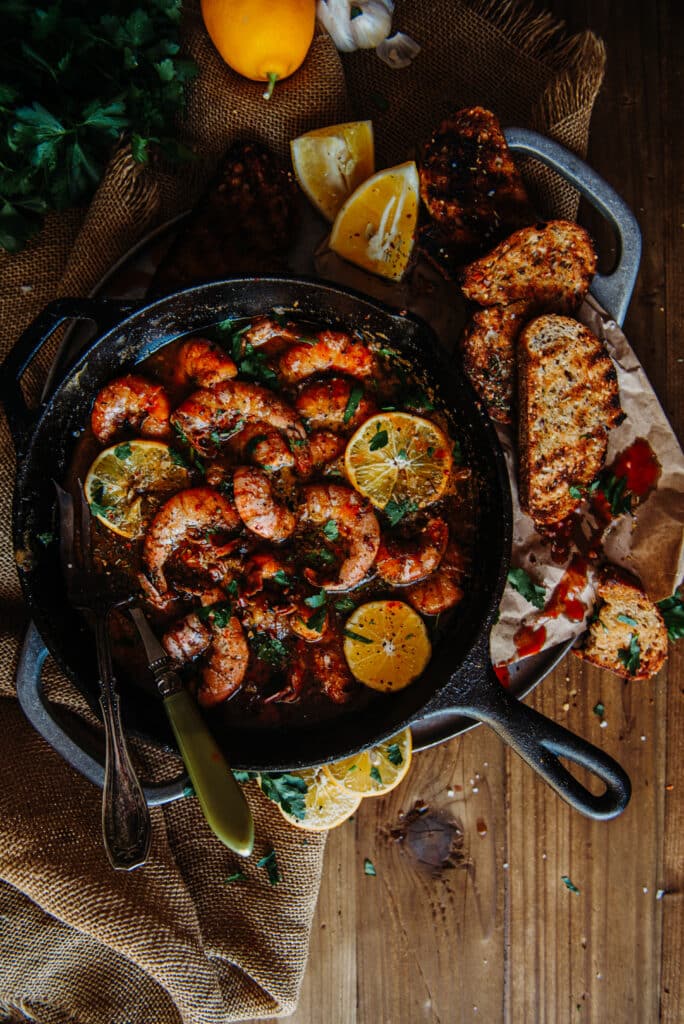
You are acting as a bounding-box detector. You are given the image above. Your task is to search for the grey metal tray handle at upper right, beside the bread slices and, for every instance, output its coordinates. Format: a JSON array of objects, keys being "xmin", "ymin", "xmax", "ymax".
[{"xmin": 504, "ymin": 128, "xmax": 641, "ymax": 327}]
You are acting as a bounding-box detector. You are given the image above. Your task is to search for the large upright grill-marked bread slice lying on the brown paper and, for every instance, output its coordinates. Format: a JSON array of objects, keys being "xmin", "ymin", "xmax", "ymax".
[{"xmin": 517, "ymin": 313, "xmax": 624, "ymax": 526}]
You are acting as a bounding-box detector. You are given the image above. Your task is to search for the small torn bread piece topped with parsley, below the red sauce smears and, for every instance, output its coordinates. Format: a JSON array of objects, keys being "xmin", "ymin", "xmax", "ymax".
[{"xmin": 574, "ymin": 565, "xmax": 668, "ymax": 680}]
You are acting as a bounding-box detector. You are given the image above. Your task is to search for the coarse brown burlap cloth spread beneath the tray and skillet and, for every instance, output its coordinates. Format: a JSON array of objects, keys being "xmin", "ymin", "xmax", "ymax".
[{"xmin": 0, "ymin": 0, "xmax": 605, "ymax": 1024}]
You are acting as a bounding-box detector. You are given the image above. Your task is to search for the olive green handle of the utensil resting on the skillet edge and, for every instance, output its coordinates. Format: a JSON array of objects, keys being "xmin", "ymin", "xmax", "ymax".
[{"xmin": 164, "ymin": 690, "xmax": 254, "ymax": 857}]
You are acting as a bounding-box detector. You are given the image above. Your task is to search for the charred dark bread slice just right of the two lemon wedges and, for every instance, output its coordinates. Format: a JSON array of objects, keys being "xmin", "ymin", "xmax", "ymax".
[{"xmin": 419, "ymin": 106, "xmax": 535, "ymax": 268}]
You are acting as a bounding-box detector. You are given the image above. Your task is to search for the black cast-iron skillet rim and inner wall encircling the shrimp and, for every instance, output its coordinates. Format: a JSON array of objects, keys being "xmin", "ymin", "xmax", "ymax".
[{"xmin": 14, "ymin": 276, "xmax": 512, "ymax": 770}]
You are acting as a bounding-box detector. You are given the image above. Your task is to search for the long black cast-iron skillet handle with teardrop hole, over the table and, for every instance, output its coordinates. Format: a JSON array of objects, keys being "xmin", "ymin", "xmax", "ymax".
[{"xmin": 459, "ymin": 665, "xmax": 632, "ymax": 821}]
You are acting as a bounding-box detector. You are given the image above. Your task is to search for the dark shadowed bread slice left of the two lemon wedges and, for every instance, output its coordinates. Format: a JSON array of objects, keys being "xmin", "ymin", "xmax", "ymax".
[{"xmin": 148, "ymin": 141, "xmax": 297, "ymax": 296}]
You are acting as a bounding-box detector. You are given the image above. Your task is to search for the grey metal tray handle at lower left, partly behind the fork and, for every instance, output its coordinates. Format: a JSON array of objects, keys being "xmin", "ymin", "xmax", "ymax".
[{"xmin": 16, "ymin": 623, "xmax": 187, "ymax": 807}]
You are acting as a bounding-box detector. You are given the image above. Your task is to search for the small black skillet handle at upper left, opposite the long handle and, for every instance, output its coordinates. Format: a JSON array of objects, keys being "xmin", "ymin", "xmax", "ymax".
[{"xmin": 0, "ymin": 298, "xmax": 135, "ymax": 456}]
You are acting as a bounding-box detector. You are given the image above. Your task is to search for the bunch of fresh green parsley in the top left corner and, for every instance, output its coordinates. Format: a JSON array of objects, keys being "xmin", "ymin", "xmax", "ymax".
[{"xmin": 0, "ymin": 0, "xmax": 198, "ymax": 252}]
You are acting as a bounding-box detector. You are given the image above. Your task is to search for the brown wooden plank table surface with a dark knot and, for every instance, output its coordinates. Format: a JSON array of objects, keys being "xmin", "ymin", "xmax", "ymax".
[{"xmin": 253, "ymin": 0, "xmax": 684, "ymax": 1024}]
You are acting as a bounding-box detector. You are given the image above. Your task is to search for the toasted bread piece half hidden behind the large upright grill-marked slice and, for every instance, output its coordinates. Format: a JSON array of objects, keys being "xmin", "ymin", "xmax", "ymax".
[{"xmin": 461, "ymin": 303, "xmax": 526, "ymax": 423}]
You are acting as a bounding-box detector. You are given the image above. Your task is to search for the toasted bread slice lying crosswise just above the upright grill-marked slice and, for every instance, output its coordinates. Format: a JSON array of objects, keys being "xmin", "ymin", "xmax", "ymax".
[{"xmin": 462, "ymin": 220, "xmax": 596, "ymax": 313}]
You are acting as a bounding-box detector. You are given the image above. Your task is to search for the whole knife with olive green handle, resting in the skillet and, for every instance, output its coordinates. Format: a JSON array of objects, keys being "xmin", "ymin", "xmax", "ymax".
[{"xmin": 129, "ymin": 608, "xmax": 254, "ymax": 857}]
